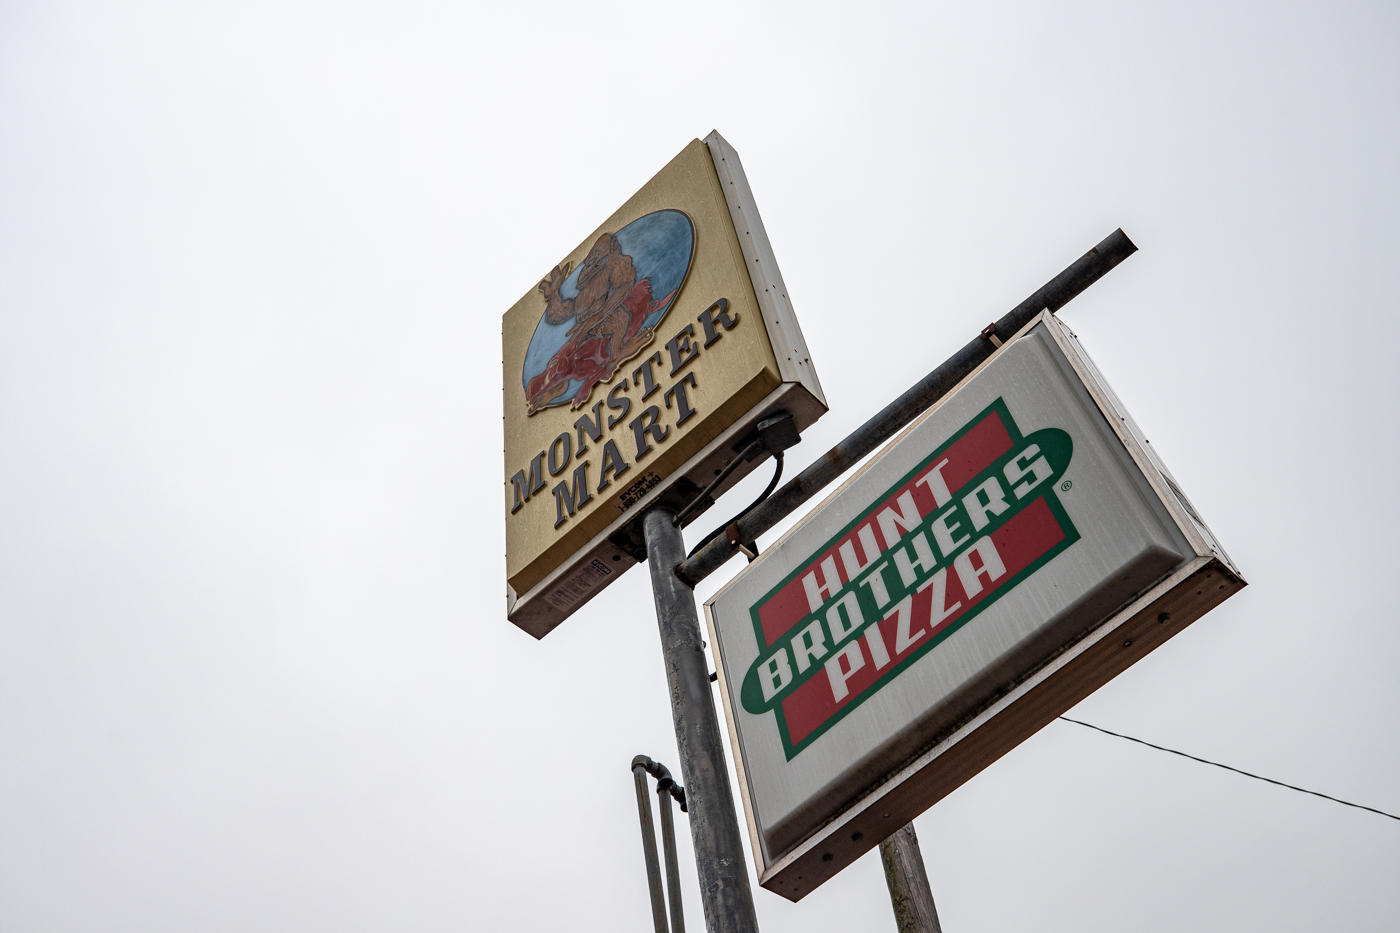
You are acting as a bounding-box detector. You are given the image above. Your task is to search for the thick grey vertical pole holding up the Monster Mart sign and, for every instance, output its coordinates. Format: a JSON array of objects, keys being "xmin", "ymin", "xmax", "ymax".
[{"xmin": 643, "ymin": 506, "xmax": 759, "ymax": 933}]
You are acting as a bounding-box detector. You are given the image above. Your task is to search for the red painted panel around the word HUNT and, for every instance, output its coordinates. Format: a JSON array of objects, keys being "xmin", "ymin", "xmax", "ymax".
[{"xmin": 759, "ymin": 412, "xmax": 1011, "ymax": 647}]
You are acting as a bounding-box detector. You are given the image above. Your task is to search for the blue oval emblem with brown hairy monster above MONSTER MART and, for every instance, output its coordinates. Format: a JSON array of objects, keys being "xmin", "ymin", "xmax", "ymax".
[{"xmin": 521, "ymin": 209, "xmax": 694, "ymax": 413}]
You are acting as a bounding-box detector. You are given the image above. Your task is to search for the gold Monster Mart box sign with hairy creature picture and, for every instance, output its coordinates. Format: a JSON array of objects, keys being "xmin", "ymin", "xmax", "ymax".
[{"xmin": 501, "ymin": 133, "xmax": 826, "ymax": 637}]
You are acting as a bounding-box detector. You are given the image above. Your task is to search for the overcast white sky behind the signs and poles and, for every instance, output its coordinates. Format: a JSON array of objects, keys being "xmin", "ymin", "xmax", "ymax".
[{"xmin": 0, "ymin": 0, "xmax": 1400, "ymax": 933}]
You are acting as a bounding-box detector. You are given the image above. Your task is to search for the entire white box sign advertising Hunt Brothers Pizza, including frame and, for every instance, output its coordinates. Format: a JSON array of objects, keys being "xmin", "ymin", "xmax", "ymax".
[{"xmin": 706, "ymin": 312, "xmax": 1245, "ymax": 901}]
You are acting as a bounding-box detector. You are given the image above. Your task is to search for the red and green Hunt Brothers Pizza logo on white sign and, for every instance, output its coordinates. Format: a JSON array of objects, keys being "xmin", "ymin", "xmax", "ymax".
[{"xmin": 741, "ymin": 398, "xmax": 1079, "ymax": 758}]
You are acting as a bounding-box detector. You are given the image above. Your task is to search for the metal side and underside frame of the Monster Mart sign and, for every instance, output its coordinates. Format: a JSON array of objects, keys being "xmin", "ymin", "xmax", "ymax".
[{"xmin": 505, "ymin": 130, "xmax": 827, "ymax": 639}]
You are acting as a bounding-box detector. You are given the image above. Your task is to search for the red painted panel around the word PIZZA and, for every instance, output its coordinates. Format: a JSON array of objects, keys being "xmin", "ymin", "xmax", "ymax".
[{"xmin": 783, "ymin": 498, "xmax": 1064, "ymax": 745}]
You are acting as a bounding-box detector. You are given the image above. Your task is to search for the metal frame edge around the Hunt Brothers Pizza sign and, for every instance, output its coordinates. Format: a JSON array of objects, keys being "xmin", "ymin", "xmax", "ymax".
[{"xmin": 704, "ymin": 311, "xmax": 1246, "ymax": 901}]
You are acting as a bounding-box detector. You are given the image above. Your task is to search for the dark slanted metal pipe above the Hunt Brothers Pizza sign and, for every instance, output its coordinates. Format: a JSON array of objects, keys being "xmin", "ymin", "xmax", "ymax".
[{"xmin": 676, "ymin": 230, "xmax": 1137, "ymax": 587}]
